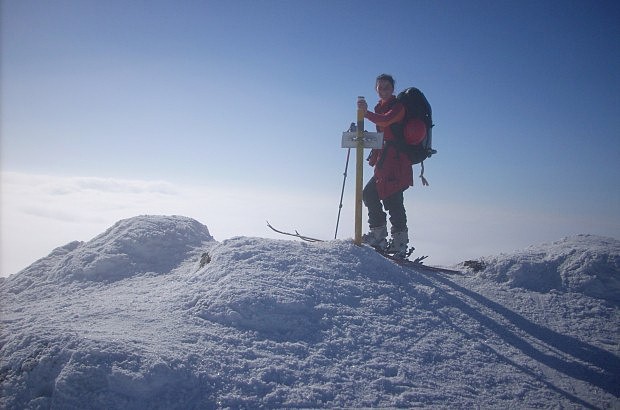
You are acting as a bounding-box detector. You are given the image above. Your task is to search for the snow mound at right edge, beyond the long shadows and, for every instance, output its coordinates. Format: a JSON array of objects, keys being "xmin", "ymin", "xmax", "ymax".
[{"xmin": 472, "ymin": 235, "xmax": 620, "ymax": 303}]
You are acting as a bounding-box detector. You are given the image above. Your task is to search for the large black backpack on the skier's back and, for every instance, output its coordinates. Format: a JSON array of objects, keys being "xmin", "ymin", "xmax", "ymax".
[{"xmin": 390, "ymin": 87, "xmax": 437, "ymax": 185}]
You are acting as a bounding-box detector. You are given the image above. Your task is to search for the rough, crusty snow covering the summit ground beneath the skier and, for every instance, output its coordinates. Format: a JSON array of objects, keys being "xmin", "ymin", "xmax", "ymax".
[{"xmin": 0, "ymin": 216, "xmax": 620, "ymax": 409}]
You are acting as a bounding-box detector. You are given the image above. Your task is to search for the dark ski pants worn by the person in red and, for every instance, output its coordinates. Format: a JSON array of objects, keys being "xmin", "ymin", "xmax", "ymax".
[{"xmin": 363, "ymin": 177, "xmax": 407, "ymax": 233}]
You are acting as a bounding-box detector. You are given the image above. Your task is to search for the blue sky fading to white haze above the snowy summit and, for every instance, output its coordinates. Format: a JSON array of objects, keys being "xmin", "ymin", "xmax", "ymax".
[{"xmin": 1, "ymin": 0, "xmax": 620, "ymax": 275}]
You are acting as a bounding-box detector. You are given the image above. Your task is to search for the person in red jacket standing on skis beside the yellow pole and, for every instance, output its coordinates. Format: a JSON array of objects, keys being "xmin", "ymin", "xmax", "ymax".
[{"xmin": 358, "ymin": 74, "xmax": 413, "ymax": 257}]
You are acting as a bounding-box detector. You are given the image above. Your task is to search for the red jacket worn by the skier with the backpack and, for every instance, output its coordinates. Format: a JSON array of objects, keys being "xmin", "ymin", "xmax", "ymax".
[{"xmin": 365, "ymin": 96, "xmax": 413, "ymax": 199}]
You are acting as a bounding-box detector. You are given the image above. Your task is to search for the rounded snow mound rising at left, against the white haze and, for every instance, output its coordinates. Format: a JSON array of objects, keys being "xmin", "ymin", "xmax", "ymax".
[{"xmin": 6, "ymin": 216, "xmax": 214, "ymax": 288}]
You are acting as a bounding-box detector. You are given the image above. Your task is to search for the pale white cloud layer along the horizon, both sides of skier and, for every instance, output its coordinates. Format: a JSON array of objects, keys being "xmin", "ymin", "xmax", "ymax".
[{"xmin": 0, "ymin": 173, "xmax": 620, "ymax": 276}]
